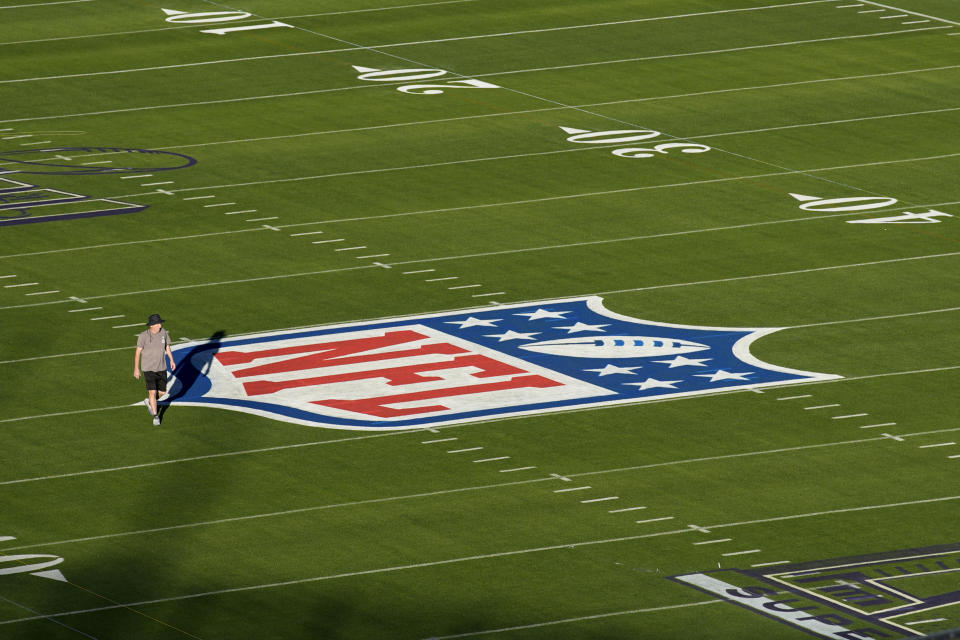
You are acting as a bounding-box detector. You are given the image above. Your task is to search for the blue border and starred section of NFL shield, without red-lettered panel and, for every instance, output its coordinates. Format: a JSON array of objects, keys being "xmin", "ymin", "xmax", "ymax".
[{"xmin": 167, "ymin": 296, "xmax": 842, "ymax": 431}]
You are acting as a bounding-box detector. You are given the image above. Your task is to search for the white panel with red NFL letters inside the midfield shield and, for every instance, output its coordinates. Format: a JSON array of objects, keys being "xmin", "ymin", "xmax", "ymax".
[{"xmin": 199, "ymin": 324, "xmax": 611, "ymax": 422}]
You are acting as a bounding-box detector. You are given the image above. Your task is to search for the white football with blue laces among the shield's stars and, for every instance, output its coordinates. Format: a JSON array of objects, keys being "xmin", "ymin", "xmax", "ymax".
[{"xmin": 520, "ymin": 336, "xmax": 710, "ymax": 358}]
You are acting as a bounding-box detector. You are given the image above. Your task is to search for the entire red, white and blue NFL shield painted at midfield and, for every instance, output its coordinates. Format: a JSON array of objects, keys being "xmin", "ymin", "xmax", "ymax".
[{"xmin": 170, "ymin": 296, "xmax": 839, "ymax": 430}]
